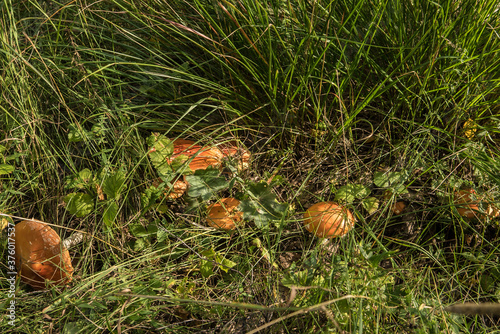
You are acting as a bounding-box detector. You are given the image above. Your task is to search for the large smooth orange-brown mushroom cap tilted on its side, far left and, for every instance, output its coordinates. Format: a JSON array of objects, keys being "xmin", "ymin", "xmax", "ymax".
[{"xmin": 14, "ymin": 220, "xmax": 73, "ymax": 290}]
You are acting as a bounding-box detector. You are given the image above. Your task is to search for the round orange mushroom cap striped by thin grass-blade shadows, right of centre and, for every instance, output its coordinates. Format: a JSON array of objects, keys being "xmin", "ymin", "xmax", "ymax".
[{"xmin": 303, "ymin": 202, "xmax": 355, "ymax": 238}]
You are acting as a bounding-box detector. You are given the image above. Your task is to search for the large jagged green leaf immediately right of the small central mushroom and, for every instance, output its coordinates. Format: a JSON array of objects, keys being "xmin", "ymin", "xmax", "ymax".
[{"xmin": 239, "ymin": 182, "xmax": 288, "ymax": 228}]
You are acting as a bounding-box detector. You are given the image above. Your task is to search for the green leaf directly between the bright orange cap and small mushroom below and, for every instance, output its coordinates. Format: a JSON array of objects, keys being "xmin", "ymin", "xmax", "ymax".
[{"xmin": 186, "ymin": 168, "xmax": 229, "ymax": 201}]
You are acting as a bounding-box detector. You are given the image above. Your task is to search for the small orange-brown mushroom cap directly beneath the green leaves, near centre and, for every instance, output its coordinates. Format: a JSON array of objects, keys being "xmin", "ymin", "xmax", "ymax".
[{"xmin": 207, "ymin": 198, "xmax": 243, "ymax": 231}]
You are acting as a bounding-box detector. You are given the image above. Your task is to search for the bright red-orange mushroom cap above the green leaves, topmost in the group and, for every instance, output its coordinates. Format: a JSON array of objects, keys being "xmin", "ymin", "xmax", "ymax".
[{"xmin": 167, "ymin": 139, "xmax": 224, "ymax": 172}]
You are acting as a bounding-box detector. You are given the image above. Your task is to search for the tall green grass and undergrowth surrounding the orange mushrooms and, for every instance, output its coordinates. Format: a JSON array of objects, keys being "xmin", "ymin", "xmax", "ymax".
[{"xmin": 0, "ymin": 0, "xmax": 500, "ymax": 333}]
